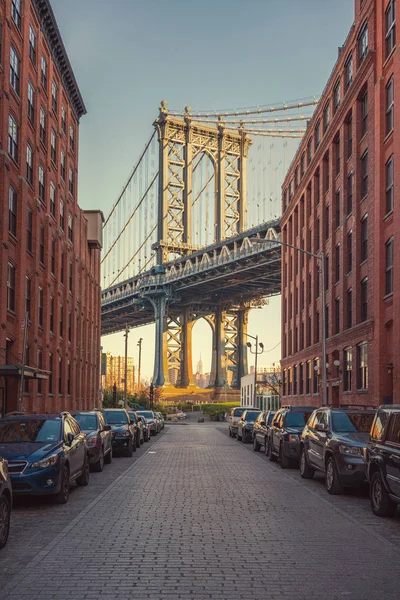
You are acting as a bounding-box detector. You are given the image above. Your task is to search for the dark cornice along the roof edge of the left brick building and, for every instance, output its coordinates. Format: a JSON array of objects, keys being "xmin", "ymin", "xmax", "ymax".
[{"xmin": 32, "ymin": 0, "xmax": 87, "ymax": 121}]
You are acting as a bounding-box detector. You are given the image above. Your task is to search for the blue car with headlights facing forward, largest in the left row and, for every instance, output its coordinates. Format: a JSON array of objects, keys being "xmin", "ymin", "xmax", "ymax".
[{"xmin": 0, "ymin": 412, "xmax": 90, "ymax": 504}]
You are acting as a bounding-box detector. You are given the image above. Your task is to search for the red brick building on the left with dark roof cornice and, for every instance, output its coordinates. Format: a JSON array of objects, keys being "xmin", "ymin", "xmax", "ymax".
[{"xmin": 0, "ymin": 0, "xmax": 102, "ymax": 413}]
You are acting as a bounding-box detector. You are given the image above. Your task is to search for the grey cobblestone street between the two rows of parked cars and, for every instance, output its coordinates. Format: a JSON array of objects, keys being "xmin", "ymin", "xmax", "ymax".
[{"xmin": 1, "ymin": 422, "xmax": 400, "ymax": 600}]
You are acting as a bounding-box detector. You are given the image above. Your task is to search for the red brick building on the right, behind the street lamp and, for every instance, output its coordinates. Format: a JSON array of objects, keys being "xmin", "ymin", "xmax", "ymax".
[{"xmin": 281, "ymin": 0, "xmax": 400, "ymax": 406}]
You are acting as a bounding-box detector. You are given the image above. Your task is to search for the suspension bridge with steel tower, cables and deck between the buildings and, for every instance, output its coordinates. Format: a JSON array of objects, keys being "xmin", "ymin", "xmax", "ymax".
[{"xmin": 101, "ymin": 98, "xmax": 318, "ymax": 392}]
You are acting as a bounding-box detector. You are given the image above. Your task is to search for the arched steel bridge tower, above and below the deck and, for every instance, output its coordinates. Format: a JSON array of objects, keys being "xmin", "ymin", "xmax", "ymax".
[{"xmin": 146, "ymin": 101, "xmax": 251, "ymax": 389}]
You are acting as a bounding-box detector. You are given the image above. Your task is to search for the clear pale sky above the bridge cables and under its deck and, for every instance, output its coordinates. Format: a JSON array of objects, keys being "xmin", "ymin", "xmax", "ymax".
[{"xmin": 51, "ymin": 0, "xmax": 354, "ymax": 377}]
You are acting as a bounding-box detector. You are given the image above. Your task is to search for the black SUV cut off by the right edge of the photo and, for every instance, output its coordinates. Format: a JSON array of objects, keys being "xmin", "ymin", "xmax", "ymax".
[{"xmin": 367, "ymin": 404, "xmax": 400, "ymax": 517}]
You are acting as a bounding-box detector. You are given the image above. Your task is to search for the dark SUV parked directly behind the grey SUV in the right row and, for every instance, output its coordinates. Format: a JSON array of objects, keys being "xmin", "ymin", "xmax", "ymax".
[{"xmin": 266, "ymin": 406, "xmax": 315, "ymax": 469}]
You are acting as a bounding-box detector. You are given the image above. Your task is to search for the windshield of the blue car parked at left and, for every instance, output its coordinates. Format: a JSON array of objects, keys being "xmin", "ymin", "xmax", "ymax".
[{"xmin": 0, "ymin": 419, "xmax": 61, "ymax": 444}]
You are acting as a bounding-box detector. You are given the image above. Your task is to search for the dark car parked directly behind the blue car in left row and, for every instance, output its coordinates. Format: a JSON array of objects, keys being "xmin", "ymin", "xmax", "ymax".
[{"xmin": 71, "ymin": 410, "xmax": 112, "ymax": 471}]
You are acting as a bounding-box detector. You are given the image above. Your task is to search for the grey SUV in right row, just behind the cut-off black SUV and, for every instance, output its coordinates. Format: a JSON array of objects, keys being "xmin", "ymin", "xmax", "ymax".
[{"xmin": 300, "ymin": 407, "xmax": 375, "ymax": 494}]
